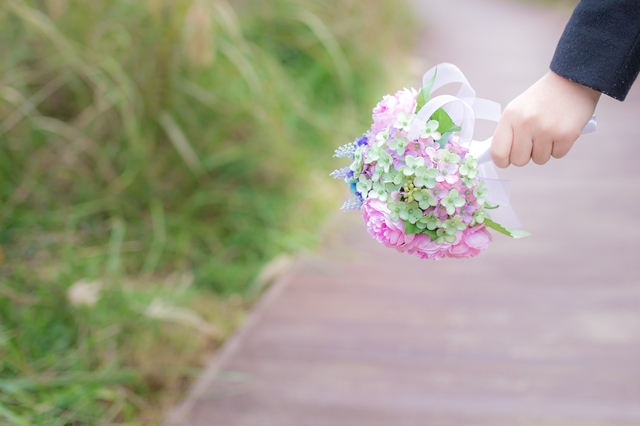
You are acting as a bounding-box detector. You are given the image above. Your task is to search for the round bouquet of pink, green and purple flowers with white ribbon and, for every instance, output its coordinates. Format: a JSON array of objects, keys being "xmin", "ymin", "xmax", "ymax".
[{"xmin": 331, "ymin": 64, "xmax": 528, "ymax": 260}]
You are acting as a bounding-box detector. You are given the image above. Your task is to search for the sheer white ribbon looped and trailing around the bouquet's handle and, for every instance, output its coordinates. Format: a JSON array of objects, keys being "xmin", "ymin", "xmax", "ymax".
[{"xmin": 407, "ymin": 62, "xmax": 596, "ymax": 228}]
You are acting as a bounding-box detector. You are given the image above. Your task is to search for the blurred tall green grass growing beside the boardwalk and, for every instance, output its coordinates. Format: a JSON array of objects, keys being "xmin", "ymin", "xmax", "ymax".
[{"xmin": 0, "ymin": 0, "xmax": 413, "ymax": 425}]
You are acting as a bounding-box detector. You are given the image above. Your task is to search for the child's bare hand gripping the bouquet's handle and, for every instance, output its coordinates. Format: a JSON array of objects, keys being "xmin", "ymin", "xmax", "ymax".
[{"xmin": 491, "ymin": 71, "xmax": 600, "ymax": 168}]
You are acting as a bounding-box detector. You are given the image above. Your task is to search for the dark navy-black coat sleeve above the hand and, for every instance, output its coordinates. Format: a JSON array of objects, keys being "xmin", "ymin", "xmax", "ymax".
[{"xmin": 551, "ymin": 0, "xmax": 640, "ymax": 101}]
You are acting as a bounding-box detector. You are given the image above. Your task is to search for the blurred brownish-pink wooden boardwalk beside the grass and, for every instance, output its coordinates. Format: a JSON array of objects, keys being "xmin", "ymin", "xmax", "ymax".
[{"xmin": 168, "ymin": 0, "xmax": 640, "ymax": 426}]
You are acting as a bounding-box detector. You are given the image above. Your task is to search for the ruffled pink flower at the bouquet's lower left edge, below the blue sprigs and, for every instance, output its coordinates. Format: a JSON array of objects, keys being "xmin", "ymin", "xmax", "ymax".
[{"xmin": 360, "ymin": 198, "xmax": 415, "ymax": 252}]
